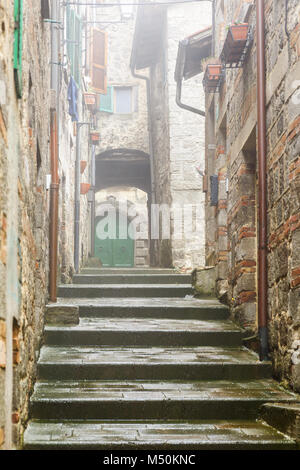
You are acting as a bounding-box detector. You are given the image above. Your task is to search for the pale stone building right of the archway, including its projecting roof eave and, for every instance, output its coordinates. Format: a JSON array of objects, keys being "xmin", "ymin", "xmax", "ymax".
[{"xmin": 131, "ymin": 2, "xmax": 211, "ymax": 270}]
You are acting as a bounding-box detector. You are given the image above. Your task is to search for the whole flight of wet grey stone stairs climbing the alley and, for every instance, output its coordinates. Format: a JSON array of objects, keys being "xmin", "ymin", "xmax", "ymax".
[{"xmin": 24, "ymin": 268, "xmax": 296, "ymax": 450}]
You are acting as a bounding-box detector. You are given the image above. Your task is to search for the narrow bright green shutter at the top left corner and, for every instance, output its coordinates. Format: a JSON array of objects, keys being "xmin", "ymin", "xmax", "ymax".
[{"xmin": 14, "ymin": 0, "xmax": 23, "ymax": 98}]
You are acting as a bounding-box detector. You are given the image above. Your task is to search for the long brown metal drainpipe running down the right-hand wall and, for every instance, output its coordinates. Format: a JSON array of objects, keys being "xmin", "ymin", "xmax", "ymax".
[{"xmin": 256, "ymin": 0, "xmax": 269, "ymax": 361}]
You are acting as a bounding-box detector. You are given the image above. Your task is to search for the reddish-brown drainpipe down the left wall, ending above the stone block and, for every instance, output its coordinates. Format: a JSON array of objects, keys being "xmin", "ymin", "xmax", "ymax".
[{"xmin": 49, "ymin": 0, "xmax": 59, "ymax": 302}]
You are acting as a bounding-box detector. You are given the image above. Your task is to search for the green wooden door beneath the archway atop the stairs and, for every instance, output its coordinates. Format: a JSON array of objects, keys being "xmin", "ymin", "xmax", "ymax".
[{"xmin": 95, "ymin": 217, "xmax": 134, "ymax": 268}]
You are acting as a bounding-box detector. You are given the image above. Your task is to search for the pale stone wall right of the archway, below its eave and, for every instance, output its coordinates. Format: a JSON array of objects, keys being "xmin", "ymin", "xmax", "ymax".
[{"xmin": 151, "ymin": 2, "xmax": 211, "ymax": 269}]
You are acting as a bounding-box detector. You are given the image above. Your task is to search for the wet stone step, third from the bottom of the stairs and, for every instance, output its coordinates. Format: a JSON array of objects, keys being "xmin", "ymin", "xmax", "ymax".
[{"xmin": 38, "ymin": 346, "xmax": 272, "ymax": 380}]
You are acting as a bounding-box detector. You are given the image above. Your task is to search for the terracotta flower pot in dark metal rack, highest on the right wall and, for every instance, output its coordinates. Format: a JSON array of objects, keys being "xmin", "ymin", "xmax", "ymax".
[{"xmin": 221, "ymin": 23, "xmax": 249, "ymax": 68}]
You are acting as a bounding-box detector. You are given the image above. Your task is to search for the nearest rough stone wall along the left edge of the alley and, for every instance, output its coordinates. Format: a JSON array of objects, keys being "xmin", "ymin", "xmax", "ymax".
[{"xmin": 0, "ymin": 0, "xmax": 50, "ymax": 448}]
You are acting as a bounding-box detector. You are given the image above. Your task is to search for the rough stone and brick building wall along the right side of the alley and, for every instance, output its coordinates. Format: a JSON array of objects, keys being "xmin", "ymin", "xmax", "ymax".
[{"xmin": 202, "ymin": 0, "xmax": 300, "ymax": 391}]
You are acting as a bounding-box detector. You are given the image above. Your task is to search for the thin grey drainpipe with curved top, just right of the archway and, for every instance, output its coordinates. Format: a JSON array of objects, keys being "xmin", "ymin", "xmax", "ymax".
[{"xmin": 131, "ymin": 67, "xmax": 156, "ymax": 265}]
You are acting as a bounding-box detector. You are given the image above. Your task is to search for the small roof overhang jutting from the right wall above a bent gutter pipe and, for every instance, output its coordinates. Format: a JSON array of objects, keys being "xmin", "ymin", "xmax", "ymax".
[{"xmin": 175, "ymin": 26, "xmax": 212, "ymax": 82}]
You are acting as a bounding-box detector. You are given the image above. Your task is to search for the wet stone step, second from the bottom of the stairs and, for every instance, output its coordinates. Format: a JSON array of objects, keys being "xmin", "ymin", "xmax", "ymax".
[{"xmin": 31, "ymin": 380, "xmax": 295, "ymax": 420}]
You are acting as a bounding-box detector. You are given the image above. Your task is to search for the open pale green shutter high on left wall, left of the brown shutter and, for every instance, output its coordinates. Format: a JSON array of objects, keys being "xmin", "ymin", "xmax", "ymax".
[{"xmin": 67, "ymin": 6, "xmax": 82, "ymax": 88}]
